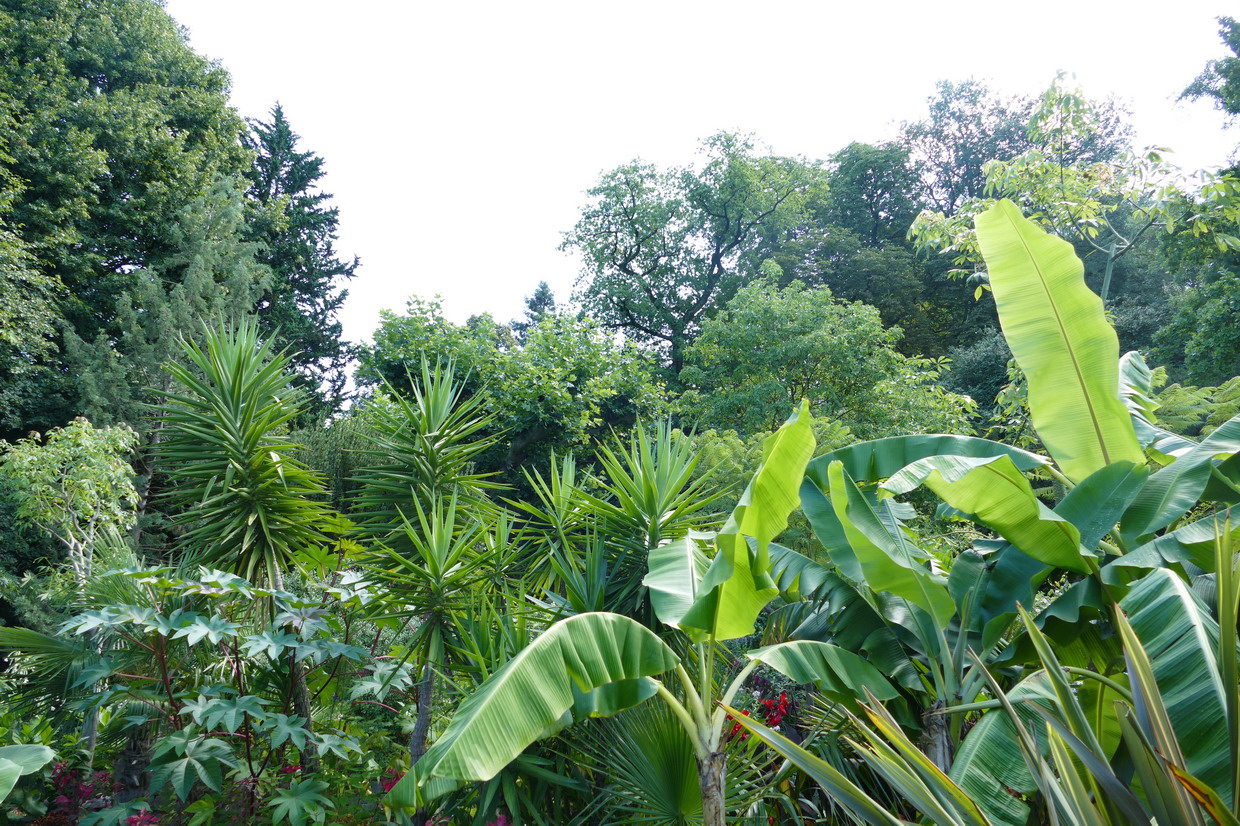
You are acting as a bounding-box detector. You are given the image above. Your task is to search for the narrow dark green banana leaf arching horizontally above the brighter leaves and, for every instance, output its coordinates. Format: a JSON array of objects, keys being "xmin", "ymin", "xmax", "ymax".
[{"xmin": 805, "ymin": 433, "xmax": 1050, "ymax": 490}]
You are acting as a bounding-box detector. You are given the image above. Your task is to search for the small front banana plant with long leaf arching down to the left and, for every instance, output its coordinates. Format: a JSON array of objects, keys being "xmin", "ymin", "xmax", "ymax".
[{"xmin": 386, "ymin": 404, "xmax": 895, "ymax": 826}]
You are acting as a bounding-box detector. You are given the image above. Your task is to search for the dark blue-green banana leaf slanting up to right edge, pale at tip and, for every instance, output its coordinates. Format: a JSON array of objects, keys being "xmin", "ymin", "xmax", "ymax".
[{"xmin": 1121, "ymin": 417, "xmax": 1240, "ymax": 538}]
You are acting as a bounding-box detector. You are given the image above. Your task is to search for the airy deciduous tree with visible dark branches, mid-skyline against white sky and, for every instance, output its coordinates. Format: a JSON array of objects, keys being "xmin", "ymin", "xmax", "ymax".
[{"xmin": 563, "ymin": 133, "xmax": 823, "ymax": 375}]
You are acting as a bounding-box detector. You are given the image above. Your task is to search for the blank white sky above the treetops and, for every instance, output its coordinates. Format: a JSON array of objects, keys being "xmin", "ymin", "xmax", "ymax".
[{"xmin": 166, "ymin": 0, "xmax": 1240, "ymax": 341}]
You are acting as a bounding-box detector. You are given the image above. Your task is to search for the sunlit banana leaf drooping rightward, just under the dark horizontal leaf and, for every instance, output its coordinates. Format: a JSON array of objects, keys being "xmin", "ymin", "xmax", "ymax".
[{"xmin": 882, "ymin": 456, "xmax": 1090, "ymax": 573}]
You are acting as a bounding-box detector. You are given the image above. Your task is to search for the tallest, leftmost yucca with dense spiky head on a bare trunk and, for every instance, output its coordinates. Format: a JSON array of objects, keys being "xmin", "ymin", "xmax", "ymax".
[{"xmin": 157, "ymin": 320, "xmax": 336, "ymax": 771}]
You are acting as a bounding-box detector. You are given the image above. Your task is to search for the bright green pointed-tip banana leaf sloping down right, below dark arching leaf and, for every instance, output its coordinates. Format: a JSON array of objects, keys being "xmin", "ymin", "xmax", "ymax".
[{"xmin": 827, "ymin": 461, "xmax": 956, "ymax": 626}]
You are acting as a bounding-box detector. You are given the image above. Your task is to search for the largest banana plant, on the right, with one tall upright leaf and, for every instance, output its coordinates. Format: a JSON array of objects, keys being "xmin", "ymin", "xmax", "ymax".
[{"xmin": 780, "ymin": 201, "xmax": 1240, "ymax": 822}]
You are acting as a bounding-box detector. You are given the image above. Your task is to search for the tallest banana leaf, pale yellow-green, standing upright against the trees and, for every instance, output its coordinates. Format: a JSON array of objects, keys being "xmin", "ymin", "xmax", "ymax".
[{"xmin": 977, "ymin": 200, "xmax": 1145, "ymax": 481}]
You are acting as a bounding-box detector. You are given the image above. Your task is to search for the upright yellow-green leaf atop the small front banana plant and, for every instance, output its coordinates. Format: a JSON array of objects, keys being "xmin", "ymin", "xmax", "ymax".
[{"xmin": 680, "ymin": 402, "xmax": 815, "ymax": 641}]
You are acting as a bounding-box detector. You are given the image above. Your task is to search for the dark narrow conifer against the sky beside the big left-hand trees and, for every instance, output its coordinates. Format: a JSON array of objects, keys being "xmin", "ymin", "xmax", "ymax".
[{"xmin": 244, "ymin": 104, "xmax": 357, "ymax": 413}]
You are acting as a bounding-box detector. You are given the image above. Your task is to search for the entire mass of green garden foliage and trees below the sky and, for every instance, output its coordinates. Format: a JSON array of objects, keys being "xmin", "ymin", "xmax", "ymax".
[{"xmin": 0, "ymin": 6, "xmax": 1240, "ymax": 826}]
